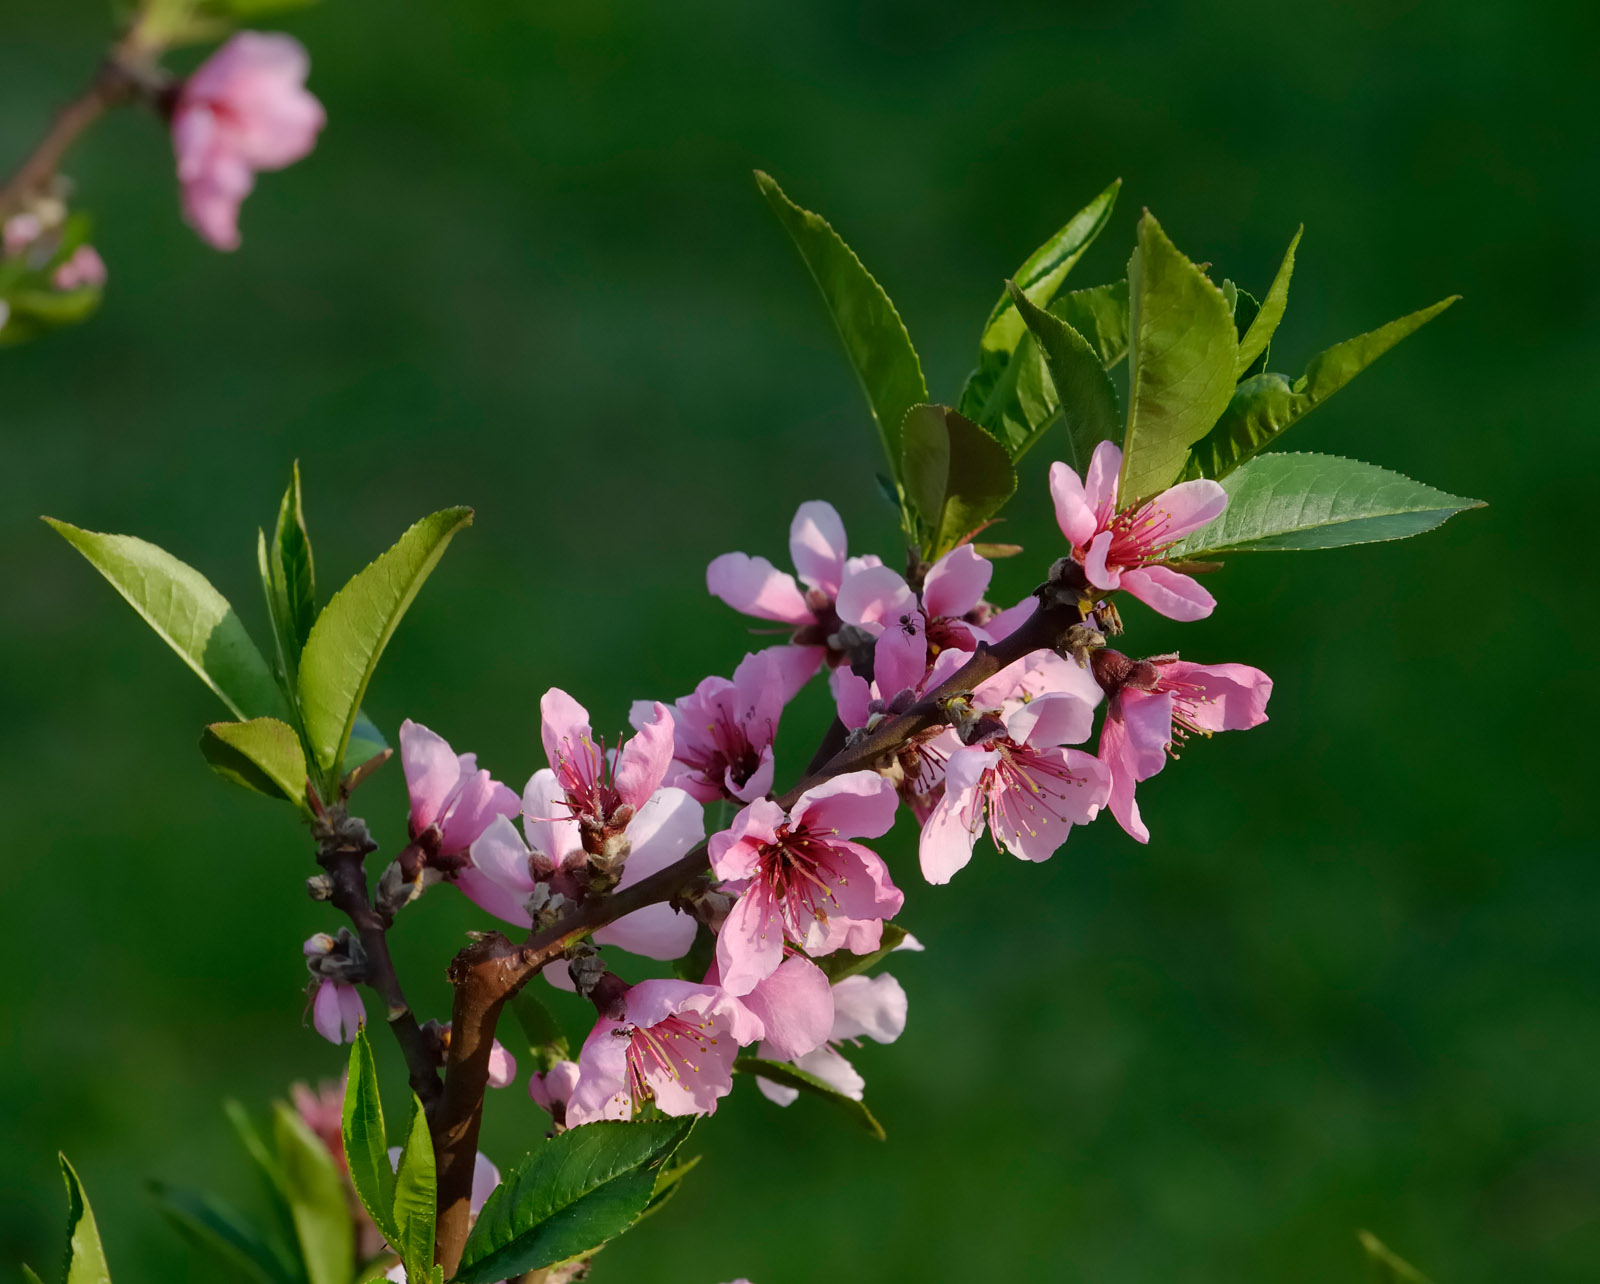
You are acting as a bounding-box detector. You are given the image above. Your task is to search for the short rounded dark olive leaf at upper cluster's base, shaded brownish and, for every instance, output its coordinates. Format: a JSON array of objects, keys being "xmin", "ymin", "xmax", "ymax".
[{"xmin": 902, "ymin": 405, "xmax": 1016, "ymax": 560}]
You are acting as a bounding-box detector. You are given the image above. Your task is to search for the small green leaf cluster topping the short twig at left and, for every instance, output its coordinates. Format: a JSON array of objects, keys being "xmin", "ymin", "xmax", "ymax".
[{"xmin": 45, "ymin": 464, "xmax": 472, "ymax": 810}]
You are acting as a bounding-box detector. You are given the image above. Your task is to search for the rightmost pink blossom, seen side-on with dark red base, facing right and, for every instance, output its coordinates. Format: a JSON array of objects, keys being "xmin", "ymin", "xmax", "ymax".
[{"xmin": 1093, "ymin": 650, "xmax": 1272, "ymax": 842}]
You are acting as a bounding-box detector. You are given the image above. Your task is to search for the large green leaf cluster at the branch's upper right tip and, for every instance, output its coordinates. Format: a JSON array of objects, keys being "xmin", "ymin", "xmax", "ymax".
[{"xmin": 757, "ymin": 175, "xmax": 1477, "ymax": 562}]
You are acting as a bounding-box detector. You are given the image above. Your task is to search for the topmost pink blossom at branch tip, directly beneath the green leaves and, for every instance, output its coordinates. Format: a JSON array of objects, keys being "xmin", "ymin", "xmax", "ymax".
[{"xmin": 1050, "ymin": 442, "xmax": 1227, "ymax": 620}]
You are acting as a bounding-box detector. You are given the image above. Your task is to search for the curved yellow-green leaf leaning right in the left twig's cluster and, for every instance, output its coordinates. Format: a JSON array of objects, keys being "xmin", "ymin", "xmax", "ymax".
[{"xmin": 299, "ymin": 508, "xmax": 472, "ymax": 780}]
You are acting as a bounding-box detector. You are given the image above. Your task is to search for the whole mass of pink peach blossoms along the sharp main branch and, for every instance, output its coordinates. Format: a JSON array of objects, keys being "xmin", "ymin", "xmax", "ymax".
[{"xmin": 307, "ymin": 443, "xmax": 1272, "ymax": 1127}]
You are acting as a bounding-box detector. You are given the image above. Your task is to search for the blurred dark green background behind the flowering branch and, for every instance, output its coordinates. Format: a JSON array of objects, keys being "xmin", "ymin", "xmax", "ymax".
[{"xmin": 0, "ymin": 0, "xmax": 1600, "ymax": 1284}]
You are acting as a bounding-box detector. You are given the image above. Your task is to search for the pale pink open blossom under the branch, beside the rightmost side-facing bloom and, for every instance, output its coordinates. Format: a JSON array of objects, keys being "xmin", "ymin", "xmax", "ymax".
[{"xmin": 920, "ymin": 693, "xmax": 1110, "ymax": 884}]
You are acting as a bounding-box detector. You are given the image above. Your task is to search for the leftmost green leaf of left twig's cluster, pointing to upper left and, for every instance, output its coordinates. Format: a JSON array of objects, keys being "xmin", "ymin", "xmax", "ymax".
[{"xmin": 45, "ymin": 517, "xmax": 288, "ymax": 719}]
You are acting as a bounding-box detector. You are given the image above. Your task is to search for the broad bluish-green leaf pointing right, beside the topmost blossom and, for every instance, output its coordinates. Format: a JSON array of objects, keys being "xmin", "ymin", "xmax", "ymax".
[{"xmin": 1168, "ymin": 455, "xmax": 1483, "ymax": 560}]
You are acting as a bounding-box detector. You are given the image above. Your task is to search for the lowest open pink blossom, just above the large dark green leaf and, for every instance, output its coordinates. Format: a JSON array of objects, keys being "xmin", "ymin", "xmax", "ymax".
[{"xmin": 566, "ymin": 980, "xmax": 762, "ymax": 1127}]
